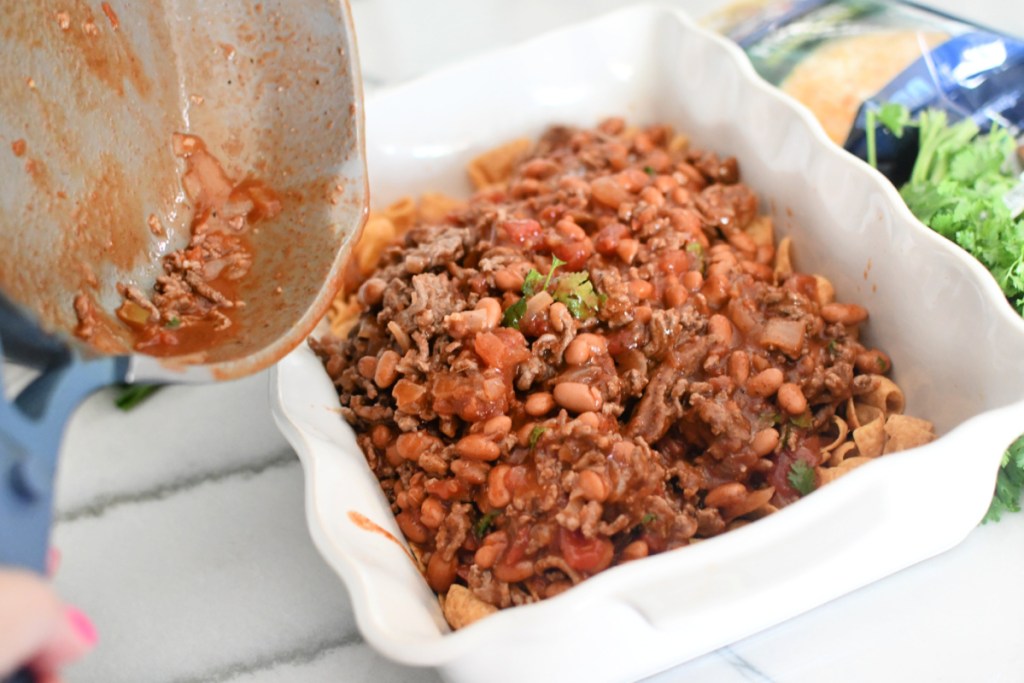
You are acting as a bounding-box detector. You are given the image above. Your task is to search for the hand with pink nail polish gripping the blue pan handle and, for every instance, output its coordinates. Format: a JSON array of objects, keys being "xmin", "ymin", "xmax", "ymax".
[{"xmin": 0, "ymin": 568, "xmax": 96, "ymax": 683}]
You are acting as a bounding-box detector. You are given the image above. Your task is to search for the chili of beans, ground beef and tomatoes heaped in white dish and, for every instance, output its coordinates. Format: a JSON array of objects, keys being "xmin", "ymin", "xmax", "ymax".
[{"xmin": 310, "ymin": 119, "xmax": 931, "ymax": 626}]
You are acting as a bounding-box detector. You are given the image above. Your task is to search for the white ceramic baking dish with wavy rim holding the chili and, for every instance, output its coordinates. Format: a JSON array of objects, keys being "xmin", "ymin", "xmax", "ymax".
[{"xmin": 272, "ymin": 7, "xmax": 1024, "ymax": 681}]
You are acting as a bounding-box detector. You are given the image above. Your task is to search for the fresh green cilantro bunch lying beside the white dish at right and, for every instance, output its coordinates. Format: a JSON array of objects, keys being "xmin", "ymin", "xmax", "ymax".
[{"xmin": 867, "ymin": 103, "xmax": 1024, "ymax": 522}]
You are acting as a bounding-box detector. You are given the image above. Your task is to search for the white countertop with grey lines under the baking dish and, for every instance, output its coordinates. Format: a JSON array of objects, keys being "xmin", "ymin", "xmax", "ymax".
[{"xmin": 32, "ymin": 0, "xmax": 1024, "ymax": 683}]
